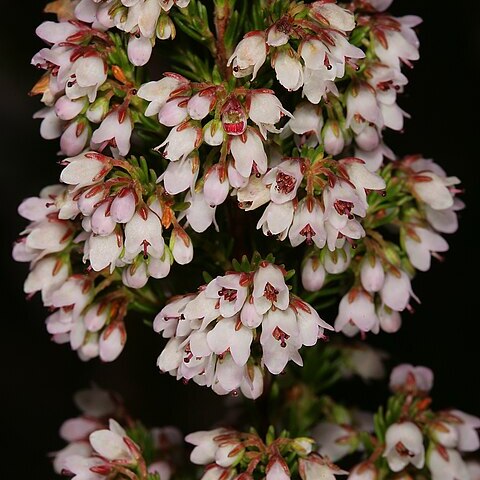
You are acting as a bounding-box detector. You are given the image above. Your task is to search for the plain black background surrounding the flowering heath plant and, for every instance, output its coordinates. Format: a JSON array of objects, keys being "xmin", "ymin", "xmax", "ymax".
[{"xmin": 0, "ymin": 0, "xmax": 480, "ymax": 478}]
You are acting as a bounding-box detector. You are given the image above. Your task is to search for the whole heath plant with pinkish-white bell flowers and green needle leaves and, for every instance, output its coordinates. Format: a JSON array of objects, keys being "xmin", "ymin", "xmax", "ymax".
[{"xmin": 13, "ymin": 0, "xmax": 480, "ymax": 480}]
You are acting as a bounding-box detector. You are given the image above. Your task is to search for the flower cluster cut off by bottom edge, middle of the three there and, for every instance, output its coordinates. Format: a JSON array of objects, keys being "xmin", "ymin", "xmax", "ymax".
[{"xmin": 185, "ymin": 428, "xmax": 347, "ymax": 480}]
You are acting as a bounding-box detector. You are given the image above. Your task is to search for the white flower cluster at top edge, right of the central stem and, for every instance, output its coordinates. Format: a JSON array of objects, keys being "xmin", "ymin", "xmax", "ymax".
[{"xmin": 228, "ymin": 1, "xmax": 365, "ymax": 98}]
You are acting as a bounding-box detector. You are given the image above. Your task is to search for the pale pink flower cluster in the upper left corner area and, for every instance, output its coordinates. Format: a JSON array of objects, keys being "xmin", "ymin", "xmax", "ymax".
[{"xmin": 31, "ymin": 16, "xmax": 136, "ymax": 156}]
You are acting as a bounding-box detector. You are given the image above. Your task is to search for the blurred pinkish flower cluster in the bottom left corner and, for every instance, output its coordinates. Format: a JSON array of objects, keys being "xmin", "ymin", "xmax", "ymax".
[{"xmin": 52, "ymin": 388, "xmax": 183, "ymax": 480}]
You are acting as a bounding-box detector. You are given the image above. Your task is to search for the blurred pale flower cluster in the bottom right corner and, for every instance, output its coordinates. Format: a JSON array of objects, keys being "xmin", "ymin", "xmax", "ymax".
[{"xmin": 316, "ymin": 364, "xmax": 480, "ymax": 480}]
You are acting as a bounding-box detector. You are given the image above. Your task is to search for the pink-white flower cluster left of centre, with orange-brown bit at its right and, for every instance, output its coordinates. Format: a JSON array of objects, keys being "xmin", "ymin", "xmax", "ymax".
[{"xmin": 60, "ymin": 152, "xmax": 193, "ymax": 288}]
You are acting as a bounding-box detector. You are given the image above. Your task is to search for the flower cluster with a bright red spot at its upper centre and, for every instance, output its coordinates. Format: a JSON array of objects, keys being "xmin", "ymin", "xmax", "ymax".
[{"xmin": 138, "ymin": 73, "xmax": 291, "ymax": 233}]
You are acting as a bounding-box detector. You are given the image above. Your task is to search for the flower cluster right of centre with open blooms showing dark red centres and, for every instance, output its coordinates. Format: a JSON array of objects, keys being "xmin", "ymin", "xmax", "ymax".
[{"xmin": 251, "ymin": 156, "xmax": 385, "ymax": 251}]
